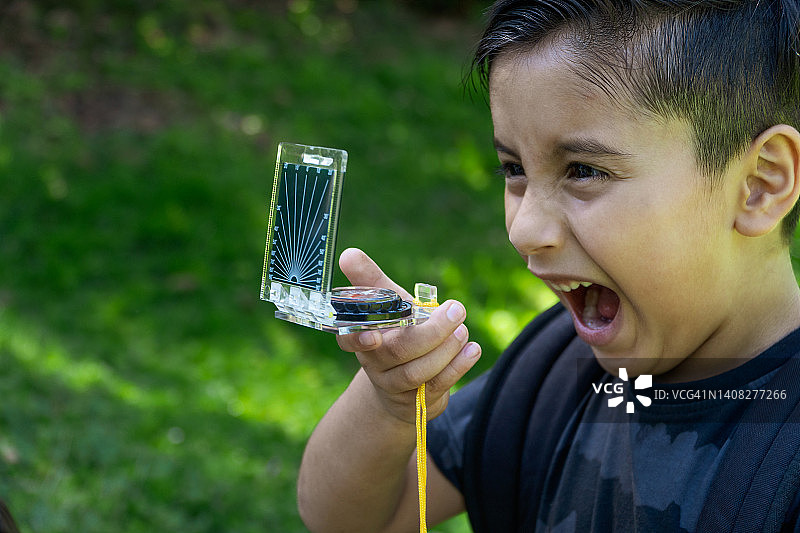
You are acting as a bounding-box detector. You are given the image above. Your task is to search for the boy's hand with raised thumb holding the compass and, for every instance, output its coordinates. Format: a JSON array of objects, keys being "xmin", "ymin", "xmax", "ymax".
[{"xmin": 337, "ymin": 248, "xmax": 481, "ymax": 424}]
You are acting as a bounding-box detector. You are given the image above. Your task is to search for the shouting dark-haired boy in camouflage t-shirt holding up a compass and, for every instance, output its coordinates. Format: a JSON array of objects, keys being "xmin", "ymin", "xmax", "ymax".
[{"xmin": 299, "ymin": 0, "xmax": 800, "ymax": 532}]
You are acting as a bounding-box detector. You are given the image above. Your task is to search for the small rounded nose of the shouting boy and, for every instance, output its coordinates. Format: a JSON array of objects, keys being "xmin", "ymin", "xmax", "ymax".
[{"xmin": 506, "ymin": 186, "xmax": 564, "ymax": 256}]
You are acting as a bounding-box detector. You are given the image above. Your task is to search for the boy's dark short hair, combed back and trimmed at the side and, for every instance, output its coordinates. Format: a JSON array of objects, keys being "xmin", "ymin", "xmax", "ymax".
[{"xmin": 472, "ymin": 0, "xmax": 800, "ymax": 242}]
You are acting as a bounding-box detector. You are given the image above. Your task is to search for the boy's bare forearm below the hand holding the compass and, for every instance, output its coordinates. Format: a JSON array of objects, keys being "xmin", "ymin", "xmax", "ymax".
[{"xmin": 298, "ymin": 370, "xmax": 415, "ymax": 532}]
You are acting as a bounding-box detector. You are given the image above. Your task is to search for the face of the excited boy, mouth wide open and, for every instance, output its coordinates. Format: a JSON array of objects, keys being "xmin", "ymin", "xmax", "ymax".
[{"xmin": 490, "ymin": 47, "xmax": 739, "ymax": 375}]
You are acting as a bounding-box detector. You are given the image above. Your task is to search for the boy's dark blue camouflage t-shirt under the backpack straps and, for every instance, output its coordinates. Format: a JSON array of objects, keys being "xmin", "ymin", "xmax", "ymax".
[{"xmin": 428, "ymin": 330, "xmax": 800, "ymax": 533}]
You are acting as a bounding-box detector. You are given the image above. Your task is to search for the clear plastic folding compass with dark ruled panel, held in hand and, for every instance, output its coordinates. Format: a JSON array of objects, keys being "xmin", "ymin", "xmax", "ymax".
[{"xmin": 261, "ymin": 143, "xmax": 438, "ymax": 334}]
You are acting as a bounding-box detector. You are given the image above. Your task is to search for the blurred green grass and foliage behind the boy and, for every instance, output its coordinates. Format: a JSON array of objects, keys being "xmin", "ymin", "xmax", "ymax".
[{"xmin": 0, "ymin": 0, "xmax": 552, "ymax": 533}]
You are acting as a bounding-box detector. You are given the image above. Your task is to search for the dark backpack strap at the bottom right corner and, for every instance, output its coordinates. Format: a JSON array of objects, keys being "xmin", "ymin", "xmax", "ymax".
[{"xmin": 697, "ymin": 352, "xmax": 800, "ymax": 533}]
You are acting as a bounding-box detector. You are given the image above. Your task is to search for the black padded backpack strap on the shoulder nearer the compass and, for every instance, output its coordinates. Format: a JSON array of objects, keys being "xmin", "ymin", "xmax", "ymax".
[{"xmin": 464, "ymin": 304, "xmax": 603, "ymax": 533}]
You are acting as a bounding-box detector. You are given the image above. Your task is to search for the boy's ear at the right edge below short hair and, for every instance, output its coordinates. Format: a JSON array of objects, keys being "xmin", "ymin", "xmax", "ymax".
[{"xmin": 734, "ymin": 124, "xmax": 800, "ymax": 237}]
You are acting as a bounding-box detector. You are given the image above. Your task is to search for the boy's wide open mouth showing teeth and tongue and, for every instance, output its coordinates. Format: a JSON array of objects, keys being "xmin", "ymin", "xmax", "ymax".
[{"xmin": 550, "ymin": 281, "xmax": 619, "ymax": 330}]
